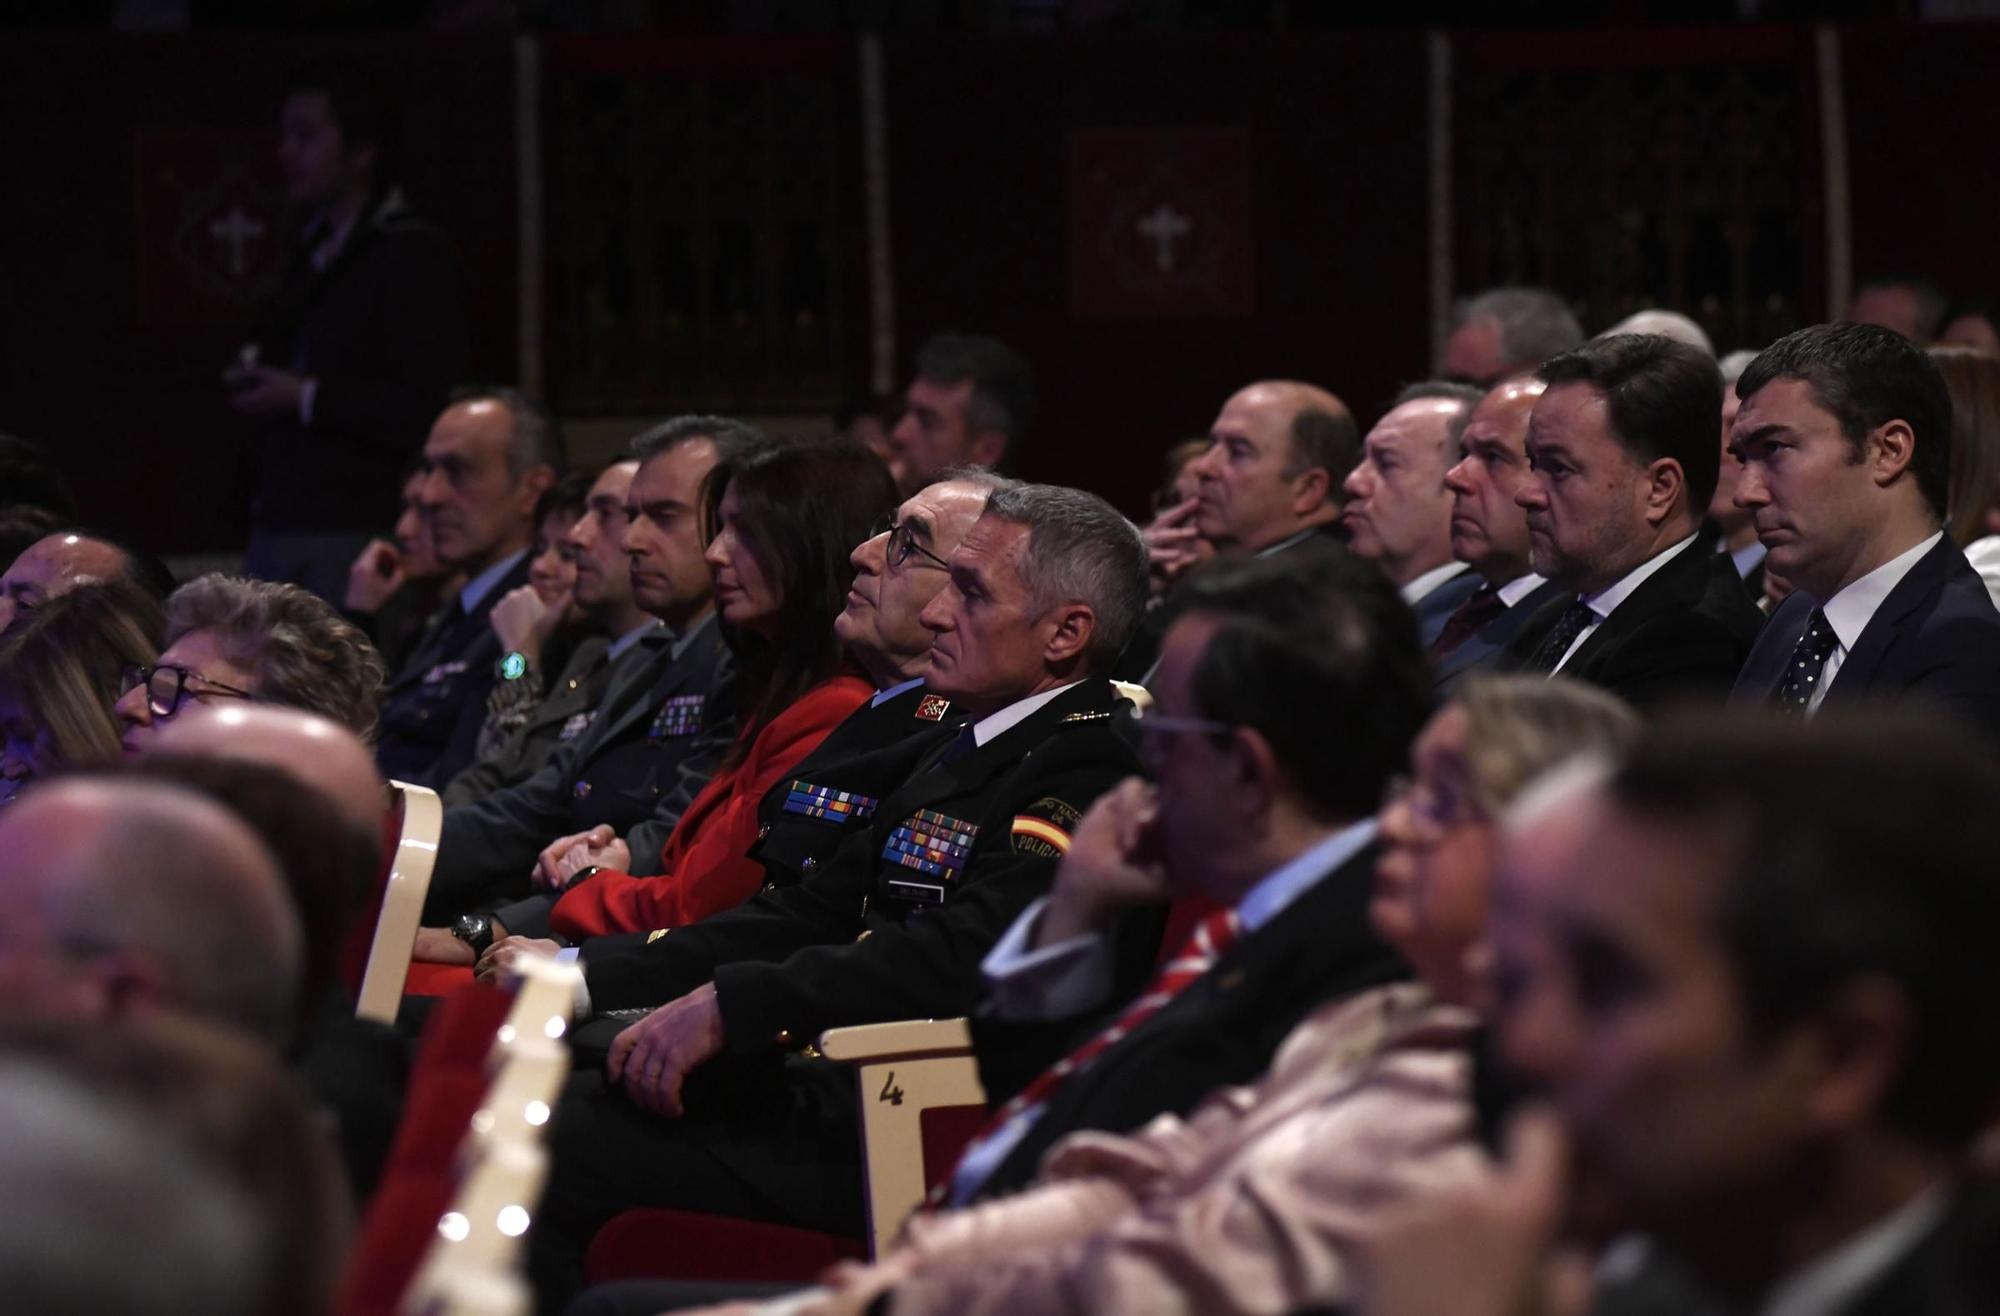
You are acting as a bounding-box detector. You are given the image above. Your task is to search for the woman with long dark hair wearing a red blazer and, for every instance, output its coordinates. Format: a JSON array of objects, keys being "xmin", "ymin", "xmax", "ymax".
[{"xmin": 432, "ymin": 440, "xmax": 896, "ymax": 964}]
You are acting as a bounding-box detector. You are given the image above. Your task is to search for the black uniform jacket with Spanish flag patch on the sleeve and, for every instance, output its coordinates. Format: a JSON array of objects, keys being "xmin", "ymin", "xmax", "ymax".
[{"xmin": 586, "ymin": 678, "xmax": 1138, "ymax": 1054}]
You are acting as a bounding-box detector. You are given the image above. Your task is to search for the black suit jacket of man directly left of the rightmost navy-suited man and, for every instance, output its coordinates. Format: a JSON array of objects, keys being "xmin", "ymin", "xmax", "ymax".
[{"xmin": 1494, "ymin": 528, "xmax": 1764, "ymax": 712}]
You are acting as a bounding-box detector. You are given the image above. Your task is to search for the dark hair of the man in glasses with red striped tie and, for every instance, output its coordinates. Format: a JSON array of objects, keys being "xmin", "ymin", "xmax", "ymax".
[{"xmin": 1170, "ymin": 546, "xmax": 1432, "ymax": 818}]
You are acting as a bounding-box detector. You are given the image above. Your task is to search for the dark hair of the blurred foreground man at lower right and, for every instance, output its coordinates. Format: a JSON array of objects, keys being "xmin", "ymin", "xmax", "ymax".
[{"xmin": 1608, "ymin": 710, "xmax": 2000, "ymax": 1148}]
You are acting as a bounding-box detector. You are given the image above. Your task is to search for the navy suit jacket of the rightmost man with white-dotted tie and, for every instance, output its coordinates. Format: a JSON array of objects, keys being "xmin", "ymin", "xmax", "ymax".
[{"xmin": 1734, "ymin": 536, "xmax": 2000, "ymax": 738}]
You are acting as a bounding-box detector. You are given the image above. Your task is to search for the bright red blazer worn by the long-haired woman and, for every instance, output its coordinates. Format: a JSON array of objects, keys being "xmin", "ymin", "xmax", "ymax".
[{"xmin": 548, "ymin": 676, "xmax": 874, "ymax": 940}]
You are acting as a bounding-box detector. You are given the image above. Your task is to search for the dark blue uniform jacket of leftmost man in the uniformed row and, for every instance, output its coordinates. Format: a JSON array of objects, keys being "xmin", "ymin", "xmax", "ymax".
[{"xmin": 376, "ymin": 552, "xmax": 528, "ymax": 790}]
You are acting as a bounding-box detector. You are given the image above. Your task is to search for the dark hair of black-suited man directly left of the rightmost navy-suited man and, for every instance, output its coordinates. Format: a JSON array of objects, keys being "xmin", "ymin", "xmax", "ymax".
[{"xmin": 1536, "ymin": 334, "xmax": 1722, "ymax": 516}]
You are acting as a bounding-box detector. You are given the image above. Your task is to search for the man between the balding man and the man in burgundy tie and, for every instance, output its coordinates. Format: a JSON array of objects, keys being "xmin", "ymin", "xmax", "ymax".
[{"xmin": 1340, "ymin": 382, "xmax": 1482, "ymax": 648}]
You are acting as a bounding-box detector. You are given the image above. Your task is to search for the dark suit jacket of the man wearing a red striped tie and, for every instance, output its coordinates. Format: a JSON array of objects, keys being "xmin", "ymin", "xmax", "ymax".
[{"xmin": 972, "ymin": 844, "xmax": 1410, "ymax": 1198}]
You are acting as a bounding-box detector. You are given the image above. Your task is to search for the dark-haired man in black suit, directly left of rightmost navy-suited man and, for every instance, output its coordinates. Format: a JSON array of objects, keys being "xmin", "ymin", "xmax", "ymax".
[{"xmin": 1496, "ymin": 334, "xmax": 1764, "ymax": 712}]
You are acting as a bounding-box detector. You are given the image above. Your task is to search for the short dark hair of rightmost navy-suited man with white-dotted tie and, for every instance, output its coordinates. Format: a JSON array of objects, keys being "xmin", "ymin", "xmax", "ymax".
[{"xmin": 1736, "ymin": 322, "xmax": 1952, "ymax": 520}]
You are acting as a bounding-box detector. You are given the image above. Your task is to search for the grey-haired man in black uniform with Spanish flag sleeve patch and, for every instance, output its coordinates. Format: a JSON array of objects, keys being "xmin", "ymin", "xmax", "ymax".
[{"xmin": 532, "ymin": 484, "xmax": 1156, "ymax": 1310}]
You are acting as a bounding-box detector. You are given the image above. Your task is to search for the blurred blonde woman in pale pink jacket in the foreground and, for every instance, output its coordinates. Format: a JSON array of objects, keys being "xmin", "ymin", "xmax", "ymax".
[{"xmin": 632, "ymin": 676, "xmax": 1638, "ymax": 1316}]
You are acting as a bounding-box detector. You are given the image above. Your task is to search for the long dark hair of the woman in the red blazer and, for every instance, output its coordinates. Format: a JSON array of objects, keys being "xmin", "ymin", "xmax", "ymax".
[{"xmin": 702, "ymin": 438, "xmax": 896, "ymax": 766}]
